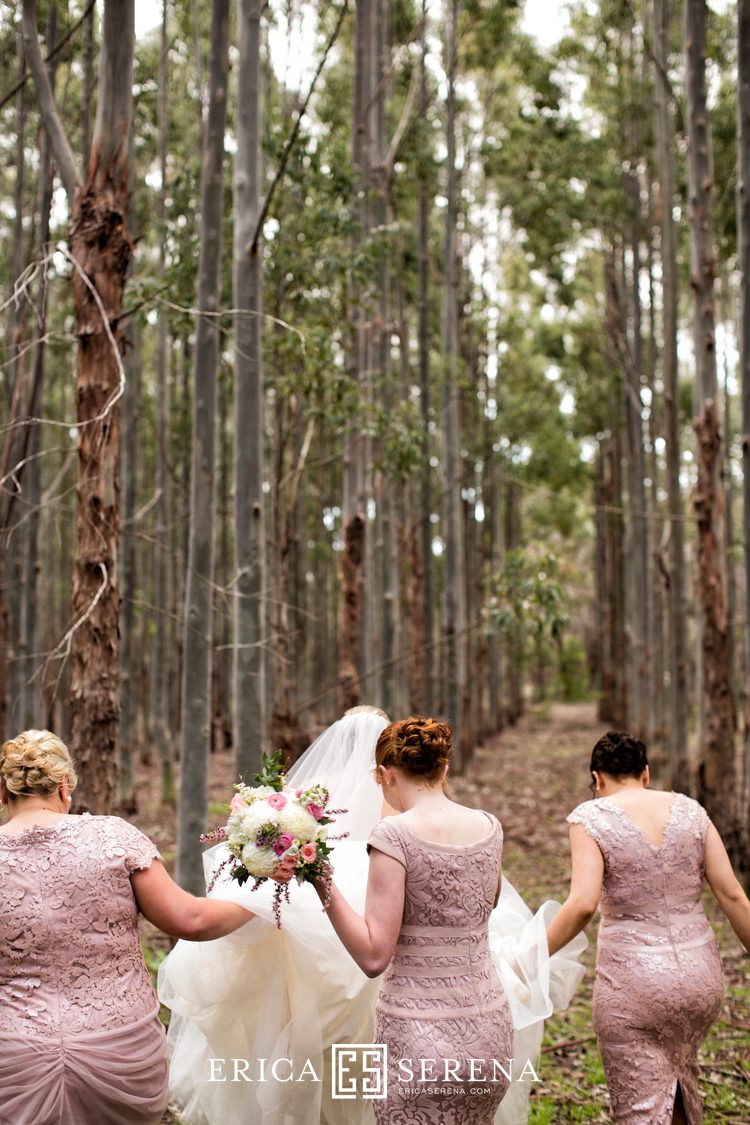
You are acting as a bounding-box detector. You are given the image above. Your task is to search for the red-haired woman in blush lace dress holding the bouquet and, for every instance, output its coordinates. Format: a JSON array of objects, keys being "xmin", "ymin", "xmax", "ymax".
[{"xmin": 275, "ymin": 718, "xmax": 523, "ymax": 1125}]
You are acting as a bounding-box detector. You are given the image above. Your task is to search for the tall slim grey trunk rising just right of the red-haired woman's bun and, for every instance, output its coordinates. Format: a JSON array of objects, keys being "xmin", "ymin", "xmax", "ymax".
[{"xmin": 443, "ymin": 0, "xmax": 468, "ymax": 772}]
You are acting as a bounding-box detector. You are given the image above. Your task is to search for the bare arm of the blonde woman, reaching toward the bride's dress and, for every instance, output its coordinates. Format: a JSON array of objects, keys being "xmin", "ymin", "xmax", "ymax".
[{"xmin": 130, "ymin": 860, "xmax": 254, "ymax": 942}]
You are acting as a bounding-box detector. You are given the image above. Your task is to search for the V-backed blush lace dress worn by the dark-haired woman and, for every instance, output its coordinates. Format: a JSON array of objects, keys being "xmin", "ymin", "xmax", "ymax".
[{"xmin": 568, "ymin": 793, "xmax": 724, "ymax": 1125}]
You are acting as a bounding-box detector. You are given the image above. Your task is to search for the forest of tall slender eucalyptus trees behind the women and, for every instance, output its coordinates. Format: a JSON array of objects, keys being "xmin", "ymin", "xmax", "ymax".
[{"xmin": 0, "ymin": 0, "xmax": 750, "ymax": 888}]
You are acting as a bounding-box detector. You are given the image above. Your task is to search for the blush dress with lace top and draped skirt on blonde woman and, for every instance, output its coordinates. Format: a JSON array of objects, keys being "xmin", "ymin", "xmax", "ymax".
[{"xmin": 0, "ymin": 813, "xmax": 168, "ymax": 1125}]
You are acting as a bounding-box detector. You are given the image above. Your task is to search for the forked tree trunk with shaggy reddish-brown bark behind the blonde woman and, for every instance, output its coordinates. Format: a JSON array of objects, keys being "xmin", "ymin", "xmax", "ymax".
[{"xmin": 22, "ymin": 0, "xmax": 135, "ymax": 812}]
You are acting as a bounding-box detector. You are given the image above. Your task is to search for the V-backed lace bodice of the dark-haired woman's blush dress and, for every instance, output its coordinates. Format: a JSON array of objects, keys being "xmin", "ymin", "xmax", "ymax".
[{"xmin": 568, "ymin": 793, "xmax": 710, "ymax": 945}]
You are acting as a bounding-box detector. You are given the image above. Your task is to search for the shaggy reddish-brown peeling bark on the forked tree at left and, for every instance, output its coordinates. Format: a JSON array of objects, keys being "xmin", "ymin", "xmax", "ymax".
[{"xmin": 70, "ymin": 189, "xmax": 132, "ymax": 812}]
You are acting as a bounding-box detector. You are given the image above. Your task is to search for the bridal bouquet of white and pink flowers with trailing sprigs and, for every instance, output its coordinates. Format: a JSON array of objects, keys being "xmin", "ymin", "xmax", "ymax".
[{"xmin": 200, "ymin": 750, "xmax": 346, "ymax": 926}]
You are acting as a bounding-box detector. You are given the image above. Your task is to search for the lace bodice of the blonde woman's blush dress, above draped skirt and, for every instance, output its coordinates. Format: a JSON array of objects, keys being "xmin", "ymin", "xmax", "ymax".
[{"xmin": 0, "ymin": 813, "xmax": 160, "ymax": 1036}]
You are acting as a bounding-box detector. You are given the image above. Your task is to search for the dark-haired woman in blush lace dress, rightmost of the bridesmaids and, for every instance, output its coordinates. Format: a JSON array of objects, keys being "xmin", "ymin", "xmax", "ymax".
[{"xmin": 548, "ymin": 731, "xmax": 750, "ymax": 1125}]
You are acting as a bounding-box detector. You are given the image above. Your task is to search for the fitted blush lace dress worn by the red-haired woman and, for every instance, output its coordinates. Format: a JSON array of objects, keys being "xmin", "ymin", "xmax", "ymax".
[{"xmin": 368, "ymin": 815, "xmax": 515, "ymax": 1125}]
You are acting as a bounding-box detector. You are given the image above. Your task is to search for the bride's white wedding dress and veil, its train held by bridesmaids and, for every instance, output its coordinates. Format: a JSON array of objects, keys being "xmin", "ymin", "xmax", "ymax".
[{"xmin": 159, "ymin": 711, "xmax": 586, "ymax": 1125}]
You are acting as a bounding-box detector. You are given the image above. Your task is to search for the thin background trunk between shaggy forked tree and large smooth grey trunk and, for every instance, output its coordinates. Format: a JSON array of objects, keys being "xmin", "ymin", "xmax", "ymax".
[{"xmin": 148, "ymin": 0, "xmax": 174, "ymax": 806}]
